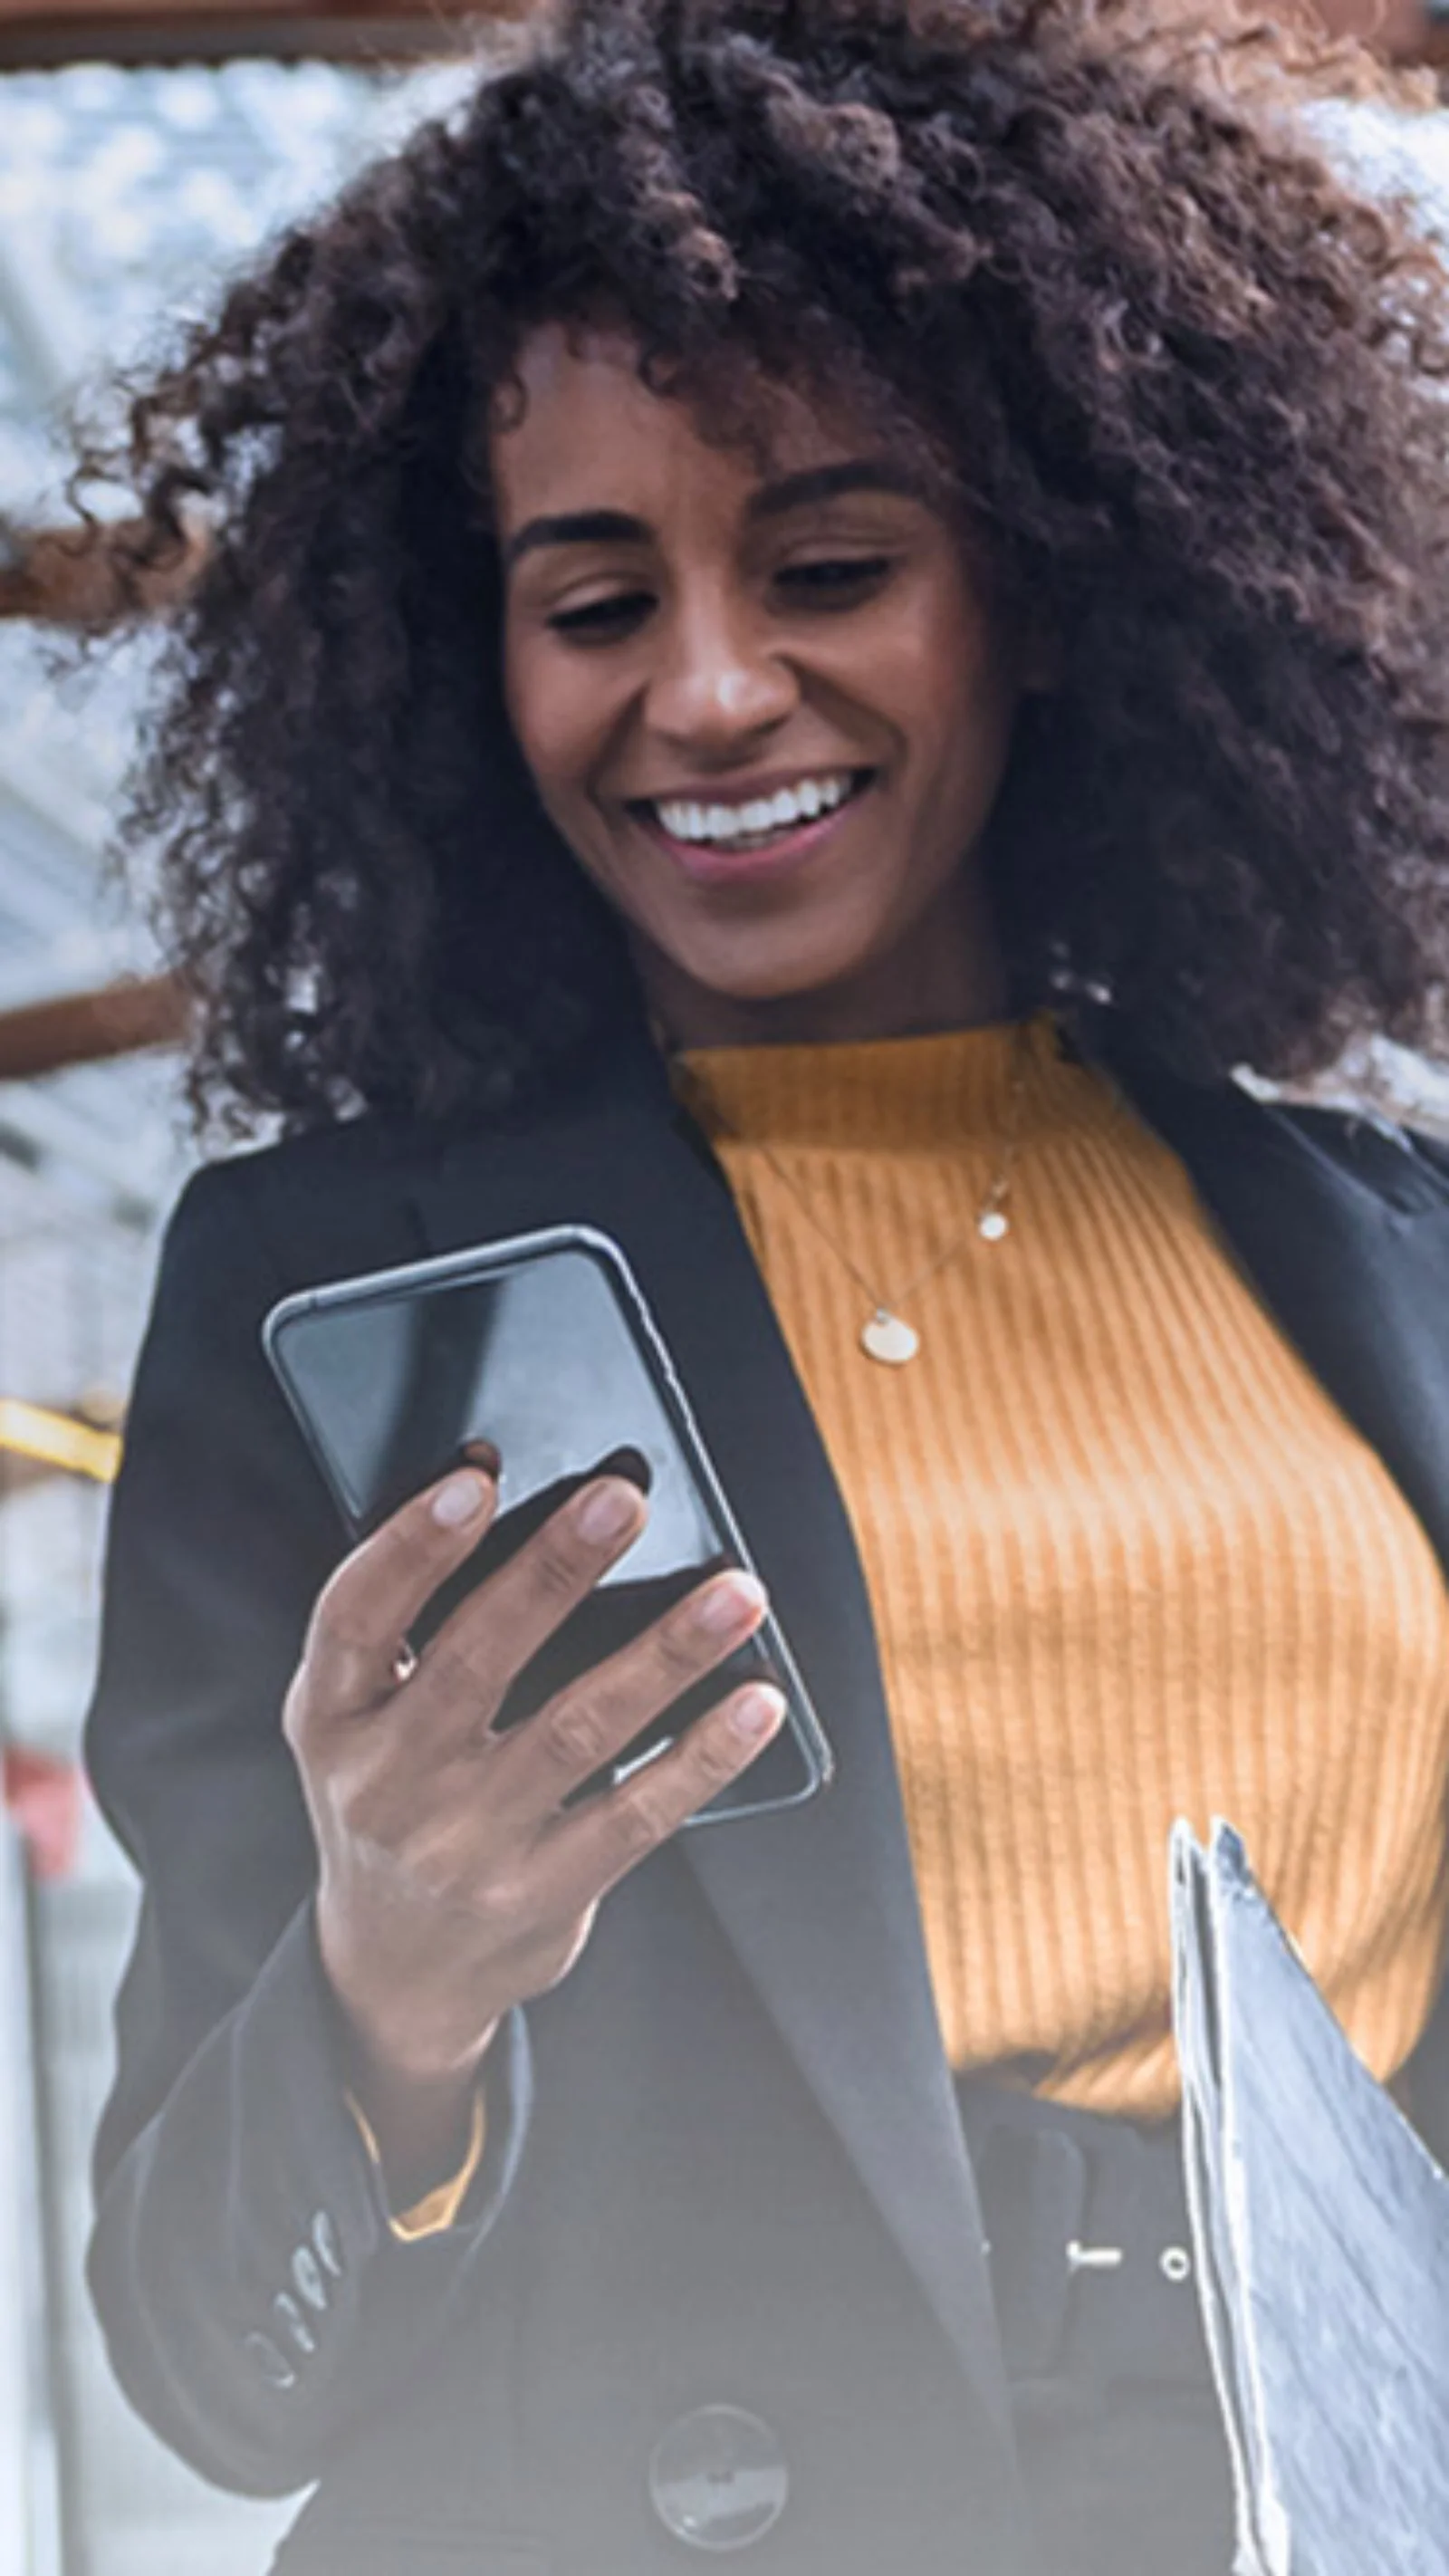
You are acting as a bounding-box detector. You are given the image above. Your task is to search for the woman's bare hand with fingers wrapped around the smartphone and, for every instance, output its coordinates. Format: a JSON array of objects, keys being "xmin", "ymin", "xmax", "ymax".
[{"xmin": 285, "ymin": 1468, "xmax": 785, "ymax": 2203}]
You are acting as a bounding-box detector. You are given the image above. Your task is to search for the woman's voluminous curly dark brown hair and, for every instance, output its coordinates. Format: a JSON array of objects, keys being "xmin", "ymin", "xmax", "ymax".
[{"xmin": 82, "ymin": 0, "xmax": 1449, "ymax": 1129}]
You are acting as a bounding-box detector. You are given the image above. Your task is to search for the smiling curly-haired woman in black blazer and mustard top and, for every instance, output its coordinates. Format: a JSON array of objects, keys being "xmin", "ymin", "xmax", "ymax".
[{"xmin": 76, "ymin": 0, "xmax": 1449, "ymax": 2576}]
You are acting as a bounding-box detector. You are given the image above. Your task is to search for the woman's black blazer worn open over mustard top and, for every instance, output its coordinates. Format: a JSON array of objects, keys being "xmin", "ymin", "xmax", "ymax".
[{"xmin": 90, "ymin": 1041, "xmax": 1449, "ymax": 2576}]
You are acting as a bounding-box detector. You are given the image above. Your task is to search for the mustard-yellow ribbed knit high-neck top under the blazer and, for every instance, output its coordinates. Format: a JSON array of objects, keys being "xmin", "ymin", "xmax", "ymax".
[{"xmin": 679, "ymin": 1020, "xmax": 1449, "ymax": 2120}]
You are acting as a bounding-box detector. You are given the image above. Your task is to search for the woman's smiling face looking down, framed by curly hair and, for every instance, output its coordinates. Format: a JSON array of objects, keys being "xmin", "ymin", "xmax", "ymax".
[{"xmin": 492, "ymin": 327, "xmax": 1019, "ymax": 1041}]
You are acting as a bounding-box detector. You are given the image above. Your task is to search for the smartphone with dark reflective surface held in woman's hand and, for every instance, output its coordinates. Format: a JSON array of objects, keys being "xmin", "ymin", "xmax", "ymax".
[{"xmin": 263, "ymin": 1226, "xmax": 834, "ymax": 1824}]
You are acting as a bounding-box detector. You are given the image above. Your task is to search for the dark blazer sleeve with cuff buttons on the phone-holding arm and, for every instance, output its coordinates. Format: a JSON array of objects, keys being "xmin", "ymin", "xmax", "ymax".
[{"xmin": 88, "ymin": 1159, "xmax": 528, "ymax": 2494}]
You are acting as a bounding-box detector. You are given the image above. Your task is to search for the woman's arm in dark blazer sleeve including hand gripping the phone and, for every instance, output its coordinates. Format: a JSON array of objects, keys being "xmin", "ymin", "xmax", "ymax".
[{"xmin": 90, "ymin": 1167, "xmax": 782, "ymax": 2491}]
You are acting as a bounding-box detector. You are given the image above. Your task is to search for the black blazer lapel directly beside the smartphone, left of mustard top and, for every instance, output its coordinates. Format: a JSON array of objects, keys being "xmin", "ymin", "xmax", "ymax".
[{"xmin": 415, "ymin": 1030, "xmax": 1009, "ymax": 2437}]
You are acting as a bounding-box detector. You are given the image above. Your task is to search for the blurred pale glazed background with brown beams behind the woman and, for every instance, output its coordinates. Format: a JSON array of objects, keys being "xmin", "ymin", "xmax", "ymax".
[{"xmin": 0, "ymin": 0, "xmax": 1449, "ymax": 2576}]
